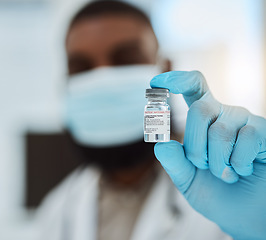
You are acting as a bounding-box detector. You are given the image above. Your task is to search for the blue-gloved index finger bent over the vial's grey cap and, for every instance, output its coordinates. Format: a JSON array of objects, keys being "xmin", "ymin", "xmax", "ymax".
[{"xmin": 150, "ymin": 71, "xmax": 209, "ymax": 107}]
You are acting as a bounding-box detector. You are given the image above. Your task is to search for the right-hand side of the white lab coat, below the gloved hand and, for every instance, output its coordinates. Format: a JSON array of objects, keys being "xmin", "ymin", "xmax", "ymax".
[{"xmin": 131, "ymin": 172, "xmax": 232, "ymax": 240}]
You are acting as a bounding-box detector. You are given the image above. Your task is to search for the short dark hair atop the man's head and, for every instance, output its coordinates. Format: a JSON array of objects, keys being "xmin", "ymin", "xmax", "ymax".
[{"xmin": 69, "ymin": 0, "xmax": 152, "ymax": 29}]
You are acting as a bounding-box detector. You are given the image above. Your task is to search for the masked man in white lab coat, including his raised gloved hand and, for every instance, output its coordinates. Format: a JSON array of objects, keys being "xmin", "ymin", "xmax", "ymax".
[{"xmin": 35, "ymin": 1, "xmax": 266, "ymax": 240}]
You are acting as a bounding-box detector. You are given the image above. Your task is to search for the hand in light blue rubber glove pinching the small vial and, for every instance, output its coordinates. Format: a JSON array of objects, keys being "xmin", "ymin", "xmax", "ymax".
[{"xmin": 150, "ymin": 71, "xmax": 266, "ymax": 240}]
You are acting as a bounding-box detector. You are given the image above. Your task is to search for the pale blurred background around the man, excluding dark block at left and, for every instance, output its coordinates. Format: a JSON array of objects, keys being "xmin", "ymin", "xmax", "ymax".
[{"xmin": 0, "ymin": 0, "xmax": 266, "ymax": 240}]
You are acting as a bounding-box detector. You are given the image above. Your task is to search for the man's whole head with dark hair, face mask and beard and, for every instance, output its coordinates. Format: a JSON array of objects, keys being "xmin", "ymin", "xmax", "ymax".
[{"xmin": 65, "ymin": 1, "xmax": 168, "ymax": 172}]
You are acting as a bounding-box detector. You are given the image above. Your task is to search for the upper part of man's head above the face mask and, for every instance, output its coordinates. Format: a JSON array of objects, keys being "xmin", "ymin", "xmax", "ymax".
[{"xmin": 66, "ymin": 1, "xmax": 162, "ymax": 75}]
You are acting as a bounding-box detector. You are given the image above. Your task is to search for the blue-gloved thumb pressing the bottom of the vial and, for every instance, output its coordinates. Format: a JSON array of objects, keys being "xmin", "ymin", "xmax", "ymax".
[{"xmin": 154, "ymin": 140, "xmax": 196, "ymax": 194}]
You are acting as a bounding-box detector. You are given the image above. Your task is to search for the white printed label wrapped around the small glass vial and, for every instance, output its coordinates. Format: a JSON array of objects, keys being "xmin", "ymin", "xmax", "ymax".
[{"xmin": 144, "ymin": 111, "xmax": 170, "ymax": 134}]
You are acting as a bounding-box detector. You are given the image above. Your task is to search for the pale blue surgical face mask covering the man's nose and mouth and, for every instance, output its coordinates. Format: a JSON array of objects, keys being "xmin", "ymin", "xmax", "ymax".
[{"xmin": 64, "ymin": 65, "xmax": 160, "ymax": 147}]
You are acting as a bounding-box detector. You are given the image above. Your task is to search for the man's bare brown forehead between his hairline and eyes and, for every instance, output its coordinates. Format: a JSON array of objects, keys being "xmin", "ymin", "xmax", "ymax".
[{"xmin": 66, "ymin": 15, "xmax": 156, "ymax": 53}]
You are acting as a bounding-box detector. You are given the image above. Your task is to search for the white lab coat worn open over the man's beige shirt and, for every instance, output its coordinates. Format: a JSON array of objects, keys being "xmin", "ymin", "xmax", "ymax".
[{"xmin": 35, "ymin": 167, "xmax": 232, "ymax": 240}]
